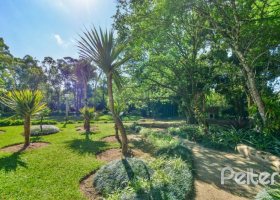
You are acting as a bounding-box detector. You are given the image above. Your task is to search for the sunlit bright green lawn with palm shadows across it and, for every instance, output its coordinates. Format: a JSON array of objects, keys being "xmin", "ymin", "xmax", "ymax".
[{"xmin": 0, "ymin": 123, "xmax": 118, "ymax": 200}]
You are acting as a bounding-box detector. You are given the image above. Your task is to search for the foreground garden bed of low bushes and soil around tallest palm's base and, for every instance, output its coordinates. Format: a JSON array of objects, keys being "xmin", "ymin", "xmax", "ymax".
[{"xmin": 80, "ymin": 129, "xmax": 193, "ymax": 200}]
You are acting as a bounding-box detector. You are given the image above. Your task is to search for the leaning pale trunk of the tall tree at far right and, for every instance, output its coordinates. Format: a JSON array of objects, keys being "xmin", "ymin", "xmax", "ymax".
[{"xmin": 234, "ymin": 46, "xmax": 266, "ymax": 125}]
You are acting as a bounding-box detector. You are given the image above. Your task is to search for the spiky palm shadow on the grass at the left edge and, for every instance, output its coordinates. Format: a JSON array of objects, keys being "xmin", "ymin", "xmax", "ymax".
[{"xmin": 0, "ymin": 151, "xmax": 27, "ymax": 172}]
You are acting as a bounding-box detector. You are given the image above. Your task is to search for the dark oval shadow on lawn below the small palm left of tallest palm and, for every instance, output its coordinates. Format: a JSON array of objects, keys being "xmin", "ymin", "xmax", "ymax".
[{"xmin": 67, "ymin": 134, "xmax": 109, "ymax": 154}]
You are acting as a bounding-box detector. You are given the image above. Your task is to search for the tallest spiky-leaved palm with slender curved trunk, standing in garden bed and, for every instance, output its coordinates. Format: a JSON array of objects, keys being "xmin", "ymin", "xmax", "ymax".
[{"xmin": 78, "ymin": 27, "xmax": 128, "ymax": 156}]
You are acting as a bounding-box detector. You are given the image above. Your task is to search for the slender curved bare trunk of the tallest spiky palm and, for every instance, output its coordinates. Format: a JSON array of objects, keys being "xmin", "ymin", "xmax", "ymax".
[{"xmin": 107, "ymin": 73, "xmax": 128, "ymax": 156}]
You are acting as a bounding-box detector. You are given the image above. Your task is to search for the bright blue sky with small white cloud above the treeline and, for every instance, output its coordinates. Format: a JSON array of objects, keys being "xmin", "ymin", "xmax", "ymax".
[{"xmin": 0, "ymin": 0, "xmax": 116, "ymax": 60}]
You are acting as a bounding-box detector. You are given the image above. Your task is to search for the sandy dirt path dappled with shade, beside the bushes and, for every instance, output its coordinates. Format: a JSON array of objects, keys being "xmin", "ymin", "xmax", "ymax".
[{"xmin": 184, "ymin": 141, "xmax": 271, "ymax": 200}]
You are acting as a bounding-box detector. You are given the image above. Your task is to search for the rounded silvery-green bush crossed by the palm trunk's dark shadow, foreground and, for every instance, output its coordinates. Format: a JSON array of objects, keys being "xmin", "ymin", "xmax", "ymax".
[{"xmin": 93, "ymin": 158, "xmax": 152, "ymax": 195}]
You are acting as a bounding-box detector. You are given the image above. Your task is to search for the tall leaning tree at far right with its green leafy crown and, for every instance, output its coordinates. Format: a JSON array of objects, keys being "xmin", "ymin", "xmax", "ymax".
[{"xmin": 194, "ymin": 0, "xmax": 280, "ymax": 124}]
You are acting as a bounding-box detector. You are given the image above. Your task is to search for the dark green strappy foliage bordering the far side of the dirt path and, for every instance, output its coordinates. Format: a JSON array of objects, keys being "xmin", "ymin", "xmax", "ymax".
[{"xmin": 171, "ymin": 125, "xmax": 280, "ymax": 155}]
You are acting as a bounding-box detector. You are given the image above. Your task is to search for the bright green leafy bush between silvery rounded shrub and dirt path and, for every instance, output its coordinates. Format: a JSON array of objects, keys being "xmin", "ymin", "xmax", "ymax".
[{"xmin": 108, "ymin": 157, "xmax": 193, "ymax": 200}]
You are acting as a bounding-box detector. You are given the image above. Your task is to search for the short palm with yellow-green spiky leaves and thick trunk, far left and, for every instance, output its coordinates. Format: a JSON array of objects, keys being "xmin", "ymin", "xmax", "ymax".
[{"xmin": 0, "ymin": 90, "xmax": 46, "ymax": 147}]
